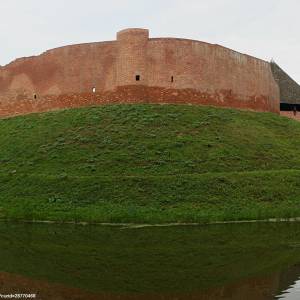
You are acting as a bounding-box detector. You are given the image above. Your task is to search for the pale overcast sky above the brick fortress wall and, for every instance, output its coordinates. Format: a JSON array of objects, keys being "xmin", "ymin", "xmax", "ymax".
[{"xmin": 0, "ymin": 0, "xmax": 300, "ymax": 83}]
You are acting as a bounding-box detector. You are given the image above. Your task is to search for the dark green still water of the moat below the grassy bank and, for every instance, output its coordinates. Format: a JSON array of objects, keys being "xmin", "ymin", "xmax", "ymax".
[{"xmin": 0, "ymin": 223, "xmax": 300, "ymax": 300}]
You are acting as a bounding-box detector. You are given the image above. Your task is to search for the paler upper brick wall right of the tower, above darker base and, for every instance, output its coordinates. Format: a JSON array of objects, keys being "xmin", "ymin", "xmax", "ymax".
[{"xmin": 148, "ymin": 39, "xmax": 279, "ymax": 110}]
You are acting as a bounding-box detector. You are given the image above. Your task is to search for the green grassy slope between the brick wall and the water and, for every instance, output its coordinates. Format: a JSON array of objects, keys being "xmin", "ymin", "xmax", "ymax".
[{"xmin": 0, "ymin": 105, "xmax": 300, "ymax": 223}]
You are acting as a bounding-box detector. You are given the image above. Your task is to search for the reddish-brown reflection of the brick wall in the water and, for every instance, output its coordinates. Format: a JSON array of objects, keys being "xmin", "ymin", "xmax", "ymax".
[{"xmin": 0, "ymin": 266, "xmax": 300, "ymax": 300}]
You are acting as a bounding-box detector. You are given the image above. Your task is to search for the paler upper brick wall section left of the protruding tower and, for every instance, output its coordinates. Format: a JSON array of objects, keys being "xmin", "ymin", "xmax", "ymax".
[{"xmin": 0, "ymin": 42, "xmax": 117, "ymax": 101}]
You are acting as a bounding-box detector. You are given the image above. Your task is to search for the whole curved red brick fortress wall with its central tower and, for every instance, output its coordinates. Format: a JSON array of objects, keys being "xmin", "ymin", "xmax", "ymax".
[{"xmin": 0, "ymin": 29, "xmax": 280, "ymax": 116}]
